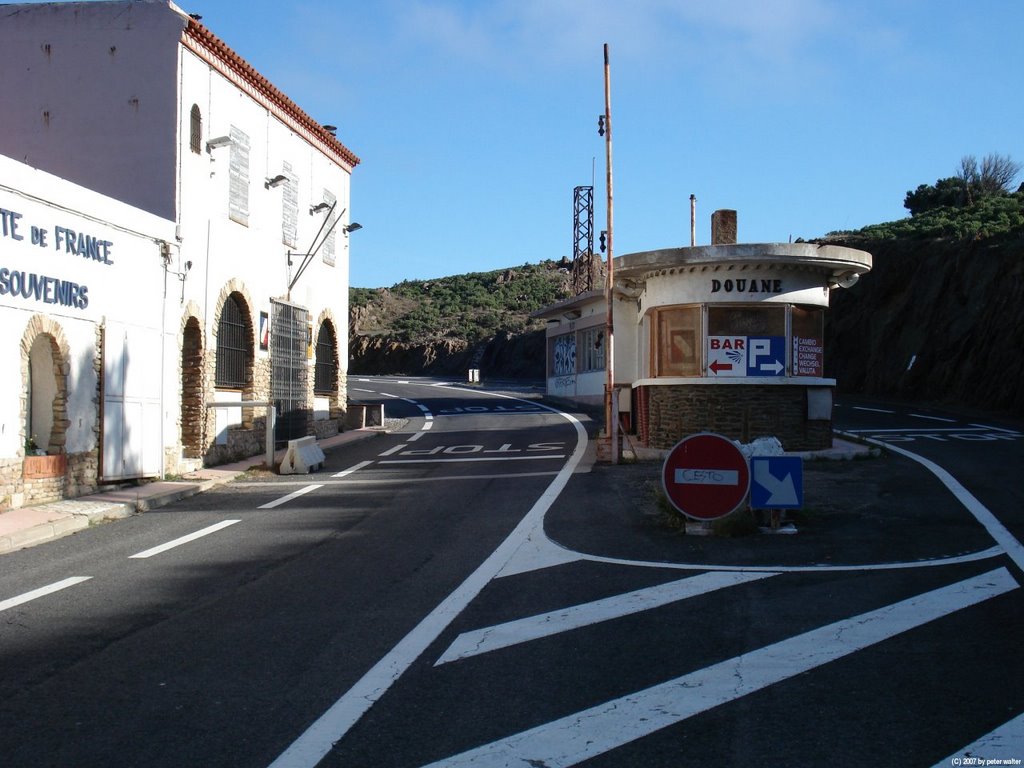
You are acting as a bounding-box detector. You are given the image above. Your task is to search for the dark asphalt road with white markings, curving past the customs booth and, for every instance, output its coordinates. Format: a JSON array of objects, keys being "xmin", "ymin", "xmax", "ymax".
[{"xmin": 0, "ymin": 379, "xmax": 1024, "ymax": 768}]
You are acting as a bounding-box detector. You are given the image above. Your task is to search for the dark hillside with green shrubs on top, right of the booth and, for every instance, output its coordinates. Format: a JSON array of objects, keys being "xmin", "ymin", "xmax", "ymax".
[{"xmin": 823, "ymin": 156, "xmax": 1024, "ymax": 416}]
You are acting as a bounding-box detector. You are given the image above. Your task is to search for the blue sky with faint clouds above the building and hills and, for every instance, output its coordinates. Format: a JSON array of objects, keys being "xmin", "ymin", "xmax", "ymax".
[{"xmin": 36, "ymin": 0, "xmax": 1024, "ymax": 288}]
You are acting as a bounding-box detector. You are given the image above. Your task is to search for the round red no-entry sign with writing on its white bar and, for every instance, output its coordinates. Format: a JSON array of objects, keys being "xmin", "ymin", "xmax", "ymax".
[{"xmin": 662, "ymin": 432, "xmax": 751, "ymax": 520}]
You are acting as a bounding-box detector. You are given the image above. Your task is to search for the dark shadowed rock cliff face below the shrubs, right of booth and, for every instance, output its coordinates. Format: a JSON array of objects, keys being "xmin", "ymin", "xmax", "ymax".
[{"xmin": 825, "ymin": 237, "xmax": 1024, "ymax": 415}]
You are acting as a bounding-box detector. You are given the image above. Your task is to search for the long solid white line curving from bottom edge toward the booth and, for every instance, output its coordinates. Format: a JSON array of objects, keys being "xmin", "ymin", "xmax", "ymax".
[{"xmin": 270, "ymin": 394, "xmax": 587, "ymax": 768}]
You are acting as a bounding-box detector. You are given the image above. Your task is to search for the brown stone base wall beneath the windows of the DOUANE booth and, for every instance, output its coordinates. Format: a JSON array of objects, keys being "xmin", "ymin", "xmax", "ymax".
[{"xmin": 636, "ymin": 384, "xmax": 833, "ymax": 451}]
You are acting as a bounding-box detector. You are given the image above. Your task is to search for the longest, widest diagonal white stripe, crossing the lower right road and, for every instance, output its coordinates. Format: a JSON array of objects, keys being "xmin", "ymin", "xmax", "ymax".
[{"xmin": 427, "ymin": 568, "xmax": 1019, "ymax": 768}]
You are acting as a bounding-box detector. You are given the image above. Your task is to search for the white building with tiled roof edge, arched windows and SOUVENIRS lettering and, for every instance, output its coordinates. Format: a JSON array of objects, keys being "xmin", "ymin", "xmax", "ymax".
[{"xmin": 0, "ymin": 0, "xmax": 359, "ymax": 507}]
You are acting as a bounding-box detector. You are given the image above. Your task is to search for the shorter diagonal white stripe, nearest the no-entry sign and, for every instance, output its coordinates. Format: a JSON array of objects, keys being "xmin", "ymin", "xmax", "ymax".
[{"xmin": 434, "ymin": 572, "xmax": 778, "ymax": 667}]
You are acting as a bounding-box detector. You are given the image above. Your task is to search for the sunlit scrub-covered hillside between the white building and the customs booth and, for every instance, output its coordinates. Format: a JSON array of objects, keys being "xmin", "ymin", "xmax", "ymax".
[{"xmin": 349, "ymin": 259, "xmax": 571, "ymax": 379}]
